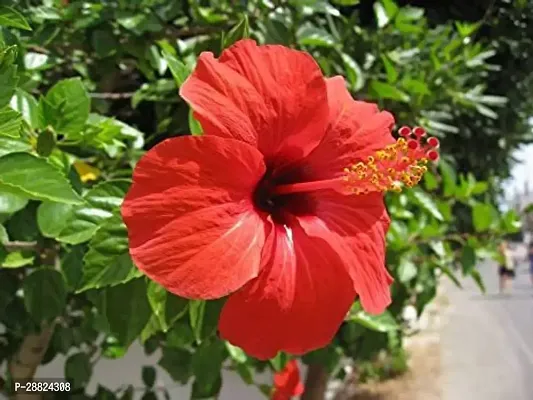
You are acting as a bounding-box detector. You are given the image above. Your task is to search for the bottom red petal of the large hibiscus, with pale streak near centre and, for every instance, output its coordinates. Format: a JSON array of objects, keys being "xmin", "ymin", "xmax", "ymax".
[{"xmin": 219, "ymin": 222, "xmax": 355, "ymax": 359}]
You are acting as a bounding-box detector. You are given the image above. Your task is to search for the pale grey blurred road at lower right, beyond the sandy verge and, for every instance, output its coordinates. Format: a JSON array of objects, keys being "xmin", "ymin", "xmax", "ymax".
[{"xmin": 441, "ymin": 249, "xmax": 533, "ymax": 400}]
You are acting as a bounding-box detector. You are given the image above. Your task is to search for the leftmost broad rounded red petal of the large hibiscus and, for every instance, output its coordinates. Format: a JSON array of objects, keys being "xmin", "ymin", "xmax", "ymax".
[{"xmin": 122, "ymin": 136, "xmax": 267, "ymax": 299}]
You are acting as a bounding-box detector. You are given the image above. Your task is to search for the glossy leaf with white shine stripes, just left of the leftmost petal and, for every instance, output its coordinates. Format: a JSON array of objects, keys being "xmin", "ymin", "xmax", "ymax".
[{"xmin": 57, "ymin": 179, "xmax": 130, "ymax": 244}]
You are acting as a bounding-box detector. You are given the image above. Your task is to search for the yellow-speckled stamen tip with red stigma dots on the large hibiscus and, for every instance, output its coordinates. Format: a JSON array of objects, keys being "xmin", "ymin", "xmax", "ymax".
[{"xmin": 342, "ymin": 126, "xmax": 439, "ymax": 194}]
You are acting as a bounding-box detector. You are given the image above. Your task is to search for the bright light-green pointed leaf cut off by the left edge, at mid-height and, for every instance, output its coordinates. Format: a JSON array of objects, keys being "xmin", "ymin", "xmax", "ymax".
[{"xmin": 0, "ymin": 153, "xmax": 81, "ymax": 204}]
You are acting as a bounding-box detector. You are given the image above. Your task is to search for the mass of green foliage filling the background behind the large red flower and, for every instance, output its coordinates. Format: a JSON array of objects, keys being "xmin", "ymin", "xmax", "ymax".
[{"xmin": 0, "ymin": 0, "xmax": 533, "ymax": 399}]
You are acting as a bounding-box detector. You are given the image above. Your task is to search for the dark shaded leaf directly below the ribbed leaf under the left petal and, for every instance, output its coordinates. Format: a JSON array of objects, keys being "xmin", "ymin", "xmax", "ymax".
[{"xmin": 105, "ymin": 278, "xmax": 152, "ymax": 346}]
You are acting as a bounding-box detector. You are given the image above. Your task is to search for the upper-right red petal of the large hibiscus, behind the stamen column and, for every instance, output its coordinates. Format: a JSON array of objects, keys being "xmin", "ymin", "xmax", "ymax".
[{"xmin": 304, "ymin": 76, "xmax": 395, "ymax": 180}]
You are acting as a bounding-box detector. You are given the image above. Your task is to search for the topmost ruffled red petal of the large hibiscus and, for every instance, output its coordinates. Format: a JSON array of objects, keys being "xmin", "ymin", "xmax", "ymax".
[{"xmin": 180, "ymin": 40, "xmax": 329, "ymax": 164}]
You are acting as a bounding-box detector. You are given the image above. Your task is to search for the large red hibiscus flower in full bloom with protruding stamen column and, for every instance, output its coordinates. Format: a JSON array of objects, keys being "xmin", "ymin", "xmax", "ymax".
[{"xmin": 122, "ymin": 40, "xmax": 438, "ymax": 359}]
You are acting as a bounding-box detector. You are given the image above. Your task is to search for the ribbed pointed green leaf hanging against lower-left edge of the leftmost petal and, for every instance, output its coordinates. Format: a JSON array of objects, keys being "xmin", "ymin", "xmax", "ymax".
[{"xmin": 78, "ymin": 215, "xmax": 140, "ymax": 290}]
